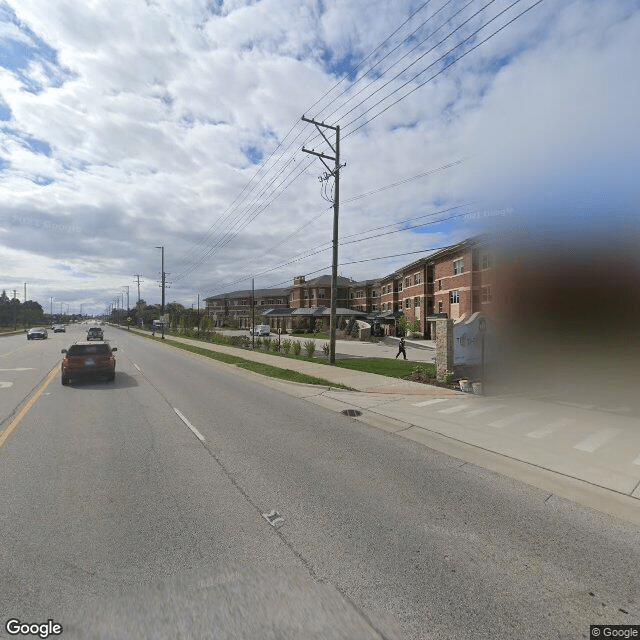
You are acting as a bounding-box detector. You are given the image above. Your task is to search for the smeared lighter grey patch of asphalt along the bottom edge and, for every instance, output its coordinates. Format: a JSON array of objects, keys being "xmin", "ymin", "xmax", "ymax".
[{"xmin": 60, "ymin": 566, "xmax": 401, "ymax": 640}]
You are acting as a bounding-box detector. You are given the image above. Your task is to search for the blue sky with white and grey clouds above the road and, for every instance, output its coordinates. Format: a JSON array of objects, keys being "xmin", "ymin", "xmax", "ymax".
[{"xmin": 0, "ymin": 0, "xmax": 640, "ymax": 313}]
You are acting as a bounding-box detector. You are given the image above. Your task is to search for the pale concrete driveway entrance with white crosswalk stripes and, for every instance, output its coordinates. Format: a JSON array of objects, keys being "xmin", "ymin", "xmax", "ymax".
[{"xmin": 398, "ymin": 394, "xmax": 640, "ymax": 495}]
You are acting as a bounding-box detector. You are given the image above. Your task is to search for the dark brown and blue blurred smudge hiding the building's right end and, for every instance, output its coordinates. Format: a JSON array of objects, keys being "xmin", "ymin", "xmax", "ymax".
[{"xmin": 487, "ymin": 212, "xmax": 640, "ymax": 410}]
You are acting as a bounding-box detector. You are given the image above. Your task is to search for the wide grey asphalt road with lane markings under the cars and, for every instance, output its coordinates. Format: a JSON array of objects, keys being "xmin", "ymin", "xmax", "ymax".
[{"xmin": 0, "ymin": 328, "xmax": 640, "ymax": 640}]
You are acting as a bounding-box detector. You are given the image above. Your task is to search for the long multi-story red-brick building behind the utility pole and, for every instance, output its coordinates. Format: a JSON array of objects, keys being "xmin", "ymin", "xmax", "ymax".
[{"xmin": 206, "ymin": 238, "xmax": 496, "ymax": 338}]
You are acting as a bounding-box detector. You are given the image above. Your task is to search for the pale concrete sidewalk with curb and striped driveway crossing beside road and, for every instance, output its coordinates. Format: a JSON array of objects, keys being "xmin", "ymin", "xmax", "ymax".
[{"xmin": 121, "ymin": 328, "xmax": 640, "ymax": 524}]
